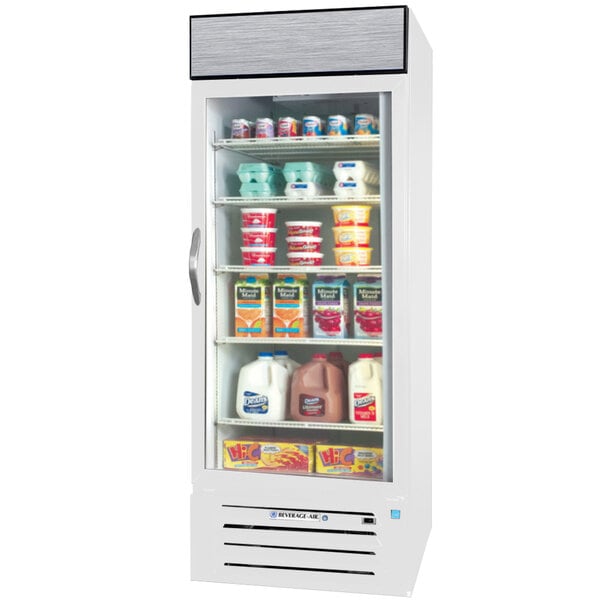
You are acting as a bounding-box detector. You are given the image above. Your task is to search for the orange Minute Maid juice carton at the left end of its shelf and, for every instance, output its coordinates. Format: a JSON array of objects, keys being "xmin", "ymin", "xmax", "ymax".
[{"xmin": 234, "ymin": 274, "xmax": 271, "ymax": 337}]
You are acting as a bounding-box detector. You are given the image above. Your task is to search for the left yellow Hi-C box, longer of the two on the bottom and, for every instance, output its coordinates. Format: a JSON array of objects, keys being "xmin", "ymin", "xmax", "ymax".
[{"xmin": 223, "ymin": 438, "xmax": 315, "ymax": 473}]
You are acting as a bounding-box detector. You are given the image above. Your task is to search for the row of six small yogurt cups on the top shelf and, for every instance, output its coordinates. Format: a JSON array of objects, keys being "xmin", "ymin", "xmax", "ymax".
[{"xmin": 231, "ymin": 113, "xmax": 379, "ymax": 139}]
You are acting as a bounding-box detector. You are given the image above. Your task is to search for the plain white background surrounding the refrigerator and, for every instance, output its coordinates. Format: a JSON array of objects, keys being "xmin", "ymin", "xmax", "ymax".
[{"xmin": 0, "ymin": 0, "xmax": 600, "ymax": 600}]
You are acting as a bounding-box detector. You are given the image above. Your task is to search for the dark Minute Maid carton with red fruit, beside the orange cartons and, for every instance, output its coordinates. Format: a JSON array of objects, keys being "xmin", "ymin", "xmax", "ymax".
[{"xmin": 312, "ymin": 275, "xmax": 350, "ymax": 338}]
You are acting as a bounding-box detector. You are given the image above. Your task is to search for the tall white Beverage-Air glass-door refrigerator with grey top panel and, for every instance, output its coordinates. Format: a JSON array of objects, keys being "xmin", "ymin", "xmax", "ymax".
[{"xmin": 190, "ymin": 6, "xmax": 431, "ymax": 596}]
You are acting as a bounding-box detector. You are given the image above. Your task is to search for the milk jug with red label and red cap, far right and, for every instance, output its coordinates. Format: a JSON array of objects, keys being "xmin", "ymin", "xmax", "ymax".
[{"xmin": 348, "ymin": 354, "xmax": 383, "ymax": 425}]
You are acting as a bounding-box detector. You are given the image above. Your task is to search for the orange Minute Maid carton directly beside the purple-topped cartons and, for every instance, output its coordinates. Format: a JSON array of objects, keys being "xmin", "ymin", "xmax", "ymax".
[{"xmin": 273, "ymin": 273, "xmax": 309, "ymax": 337}]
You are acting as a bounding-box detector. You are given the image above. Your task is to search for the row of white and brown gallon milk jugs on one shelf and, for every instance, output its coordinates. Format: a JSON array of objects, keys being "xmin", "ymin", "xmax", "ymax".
[{"xmin": 236, "ymin": 350, "xmax": 383, "ymax": 425}]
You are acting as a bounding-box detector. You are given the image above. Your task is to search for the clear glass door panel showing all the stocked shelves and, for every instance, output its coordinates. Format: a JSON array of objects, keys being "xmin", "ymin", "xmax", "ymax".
[{"xmin": 206, "ymin": 92, "xmax": 392, "ymax": 482}]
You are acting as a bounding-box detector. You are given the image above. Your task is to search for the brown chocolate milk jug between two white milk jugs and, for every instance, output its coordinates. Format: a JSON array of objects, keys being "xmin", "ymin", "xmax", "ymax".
[{"xmin": 290, "ymin": 354, "xmax": 346, "ymax": 423}]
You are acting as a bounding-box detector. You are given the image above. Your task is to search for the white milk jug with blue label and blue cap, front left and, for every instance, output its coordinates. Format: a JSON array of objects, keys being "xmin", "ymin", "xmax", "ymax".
[{"xmin": 236, "ymin": 352, "xmax": 290, "ymax": 421}]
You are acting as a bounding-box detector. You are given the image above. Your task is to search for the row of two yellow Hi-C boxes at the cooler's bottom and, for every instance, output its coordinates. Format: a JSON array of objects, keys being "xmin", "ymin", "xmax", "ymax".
[{"xmin": 223, "ymin": 438, "xmax": 383, "ymax": 479}]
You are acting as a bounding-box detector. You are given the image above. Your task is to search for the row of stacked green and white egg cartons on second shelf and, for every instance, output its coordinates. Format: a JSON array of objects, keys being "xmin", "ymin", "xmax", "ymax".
[{"xmin": 236, "ymin": 160, "xmax": 379, "ymax": 198}]
